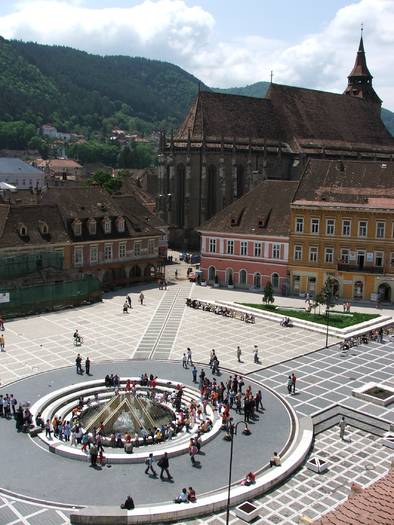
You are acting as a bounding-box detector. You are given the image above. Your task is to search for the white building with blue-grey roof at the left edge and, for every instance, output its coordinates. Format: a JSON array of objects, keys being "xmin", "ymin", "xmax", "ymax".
[{"xmin": 0, "ymin": 157, "xmax": 45, "ymax": 190}]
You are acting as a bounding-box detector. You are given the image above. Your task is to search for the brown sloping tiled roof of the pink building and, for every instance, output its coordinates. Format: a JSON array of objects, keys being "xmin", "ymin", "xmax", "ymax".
[{"xmin": 199, "ymin": 180, "xmax": 298, "ymax": 236}]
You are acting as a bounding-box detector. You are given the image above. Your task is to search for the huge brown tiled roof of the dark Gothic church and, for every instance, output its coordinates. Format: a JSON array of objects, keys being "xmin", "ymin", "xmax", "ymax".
[{"xmin": 176, "ymin": 84, "xmax": 394, "ymax": 152}]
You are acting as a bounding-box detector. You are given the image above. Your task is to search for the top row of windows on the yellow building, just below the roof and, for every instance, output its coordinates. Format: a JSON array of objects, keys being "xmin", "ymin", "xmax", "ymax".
[{"xmin": 295, "ymin": 217, "xmax": 388, "ymax": 239}]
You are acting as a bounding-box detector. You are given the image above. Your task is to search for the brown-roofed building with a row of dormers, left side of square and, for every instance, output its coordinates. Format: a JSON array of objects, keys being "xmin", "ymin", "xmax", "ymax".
[{"xmin": 0, "ymin": 187, "xmax": 164, "ymax": 290}]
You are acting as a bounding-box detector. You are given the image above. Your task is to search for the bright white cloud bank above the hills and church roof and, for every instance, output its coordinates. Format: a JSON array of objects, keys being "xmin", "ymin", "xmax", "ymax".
[{"xmin": 0, "ymin": 0, "xmax": 394, "ymax": 109}]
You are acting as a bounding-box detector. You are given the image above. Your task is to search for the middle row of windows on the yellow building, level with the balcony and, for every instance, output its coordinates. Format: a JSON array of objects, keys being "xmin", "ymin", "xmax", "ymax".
[{"xmin": 294, "ymin": 245, "xmax": 386, "ymax": 266}]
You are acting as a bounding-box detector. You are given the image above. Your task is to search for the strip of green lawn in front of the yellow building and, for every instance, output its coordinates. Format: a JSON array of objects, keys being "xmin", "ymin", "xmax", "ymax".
[{"xmin": 241, "ymin": 303, "xmax": 379, "ymax": 328}]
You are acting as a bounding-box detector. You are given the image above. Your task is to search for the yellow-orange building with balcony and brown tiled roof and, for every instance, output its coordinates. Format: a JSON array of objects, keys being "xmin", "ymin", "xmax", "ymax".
[{"xmin": 289, "ymin": 160, "xmax": 394, "ymax": 302}]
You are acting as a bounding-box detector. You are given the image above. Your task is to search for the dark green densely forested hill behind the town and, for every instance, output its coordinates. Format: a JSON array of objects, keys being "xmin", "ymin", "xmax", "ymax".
[{"xmin": 0, "ymin": 37, "xmax": 394, "ymax": 148}]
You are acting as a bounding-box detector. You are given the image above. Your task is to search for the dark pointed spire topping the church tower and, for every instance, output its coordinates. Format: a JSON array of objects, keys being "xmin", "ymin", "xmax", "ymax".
[{"xmin": 344, "ymin": 29, "xmax": 382, "ymax": 105}]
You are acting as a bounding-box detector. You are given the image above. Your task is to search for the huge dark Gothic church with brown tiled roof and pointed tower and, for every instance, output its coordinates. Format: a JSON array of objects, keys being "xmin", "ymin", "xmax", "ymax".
[{"xmin": 157, "ymin": 35, "xmax": 394, "ymax": 249}]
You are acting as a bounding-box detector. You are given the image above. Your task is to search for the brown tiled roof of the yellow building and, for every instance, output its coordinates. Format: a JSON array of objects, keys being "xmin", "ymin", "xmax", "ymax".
[{"xmin": 294, "ymin": 159, "xmax": 394, "ymax": 204}]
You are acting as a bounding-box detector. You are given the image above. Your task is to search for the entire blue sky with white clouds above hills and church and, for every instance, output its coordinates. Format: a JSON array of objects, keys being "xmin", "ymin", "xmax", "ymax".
[{"xmin": 0, "ymin": 0, "xmax": 394, "ymax": 110}]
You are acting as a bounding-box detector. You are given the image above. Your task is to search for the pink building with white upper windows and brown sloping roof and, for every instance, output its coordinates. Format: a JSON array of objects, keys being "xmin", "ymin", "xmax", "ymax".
[{"xmin": 199, "ymin": 180, "xmax": 297, "ymax": 293}]
